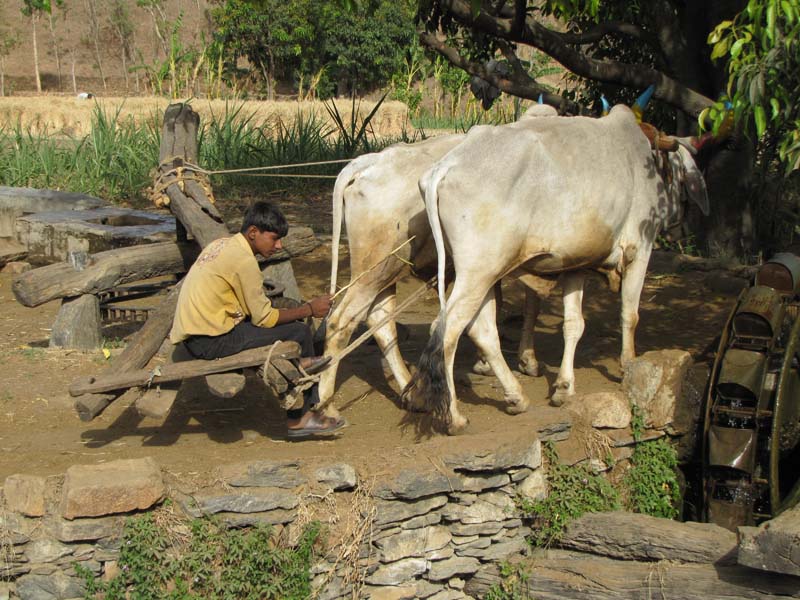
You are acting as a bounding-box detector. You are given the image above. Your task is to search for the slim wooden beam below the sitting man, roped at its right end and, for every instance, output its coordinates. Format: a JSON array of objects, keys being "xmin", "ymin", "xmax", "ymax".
[{"xmin": 69, "ymin": 342, "xmax": 300, "ymax": 396}]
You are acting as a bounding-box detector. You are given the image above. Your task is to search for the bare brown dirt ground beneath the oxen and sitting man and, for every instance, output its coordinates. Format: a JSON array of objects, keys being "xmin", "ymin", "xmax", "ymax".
[{"xmin": 0, "ymin": 206, "xmax": 735, "ymax": 481}]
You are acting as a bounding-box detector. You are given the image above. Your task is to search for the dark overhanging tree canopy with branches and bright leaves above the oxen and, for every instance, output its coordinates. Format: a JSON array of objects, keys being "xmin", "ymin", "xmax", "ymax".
[{"xmin": 418, "ymin": 0, "xmax": 800, "ymax": 175}]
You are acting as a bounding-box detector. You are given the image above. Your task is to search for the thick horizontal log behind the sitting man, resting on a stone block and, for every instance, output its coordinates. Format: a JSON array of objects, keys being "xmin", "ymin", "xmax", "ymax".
[{"xmin": 11, "ymin": 242, "xmax": 198, "ymax": 306}]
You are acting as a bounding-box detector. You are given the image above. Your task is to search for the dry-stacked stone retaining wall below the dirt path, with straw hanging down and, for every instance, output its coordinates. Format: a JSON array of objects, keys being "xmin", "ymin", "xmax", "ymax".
[{"xmin": 0, "ymin": 432, "xmax": 563, "ymax": 600}]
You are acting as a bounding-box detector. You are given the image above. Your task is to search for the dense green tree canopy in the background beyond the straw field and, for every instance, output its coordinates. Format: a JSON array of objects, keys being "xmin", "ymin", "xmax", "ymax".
[{"xmin": 212, "ymin": 0, "xmax": 416, "ymax": 97}]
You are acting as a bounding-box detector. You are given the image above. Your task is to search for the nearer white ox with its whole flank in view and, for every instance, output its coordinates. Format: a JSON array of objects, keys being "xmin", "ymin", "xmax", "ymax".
[{"xmin": 404, "ymin": 106, "xmax": 708, "ymax": 433}]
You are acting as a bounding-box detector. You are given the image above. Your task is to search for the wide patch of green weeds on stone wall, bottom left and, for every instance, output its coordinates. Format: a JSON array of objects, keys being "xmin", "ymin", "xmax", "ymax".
[{"xmin": 75, "ymin": 506, "xmax": 321, "ymax": 600}]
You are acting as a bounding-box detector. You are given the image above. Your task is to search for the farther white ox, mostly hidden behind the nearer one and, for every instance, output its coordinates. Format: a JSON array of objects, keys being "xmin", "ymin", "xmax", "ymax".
[{"xmin": 319, "ymin": 105, "xmax": 557, "ymax": 409}]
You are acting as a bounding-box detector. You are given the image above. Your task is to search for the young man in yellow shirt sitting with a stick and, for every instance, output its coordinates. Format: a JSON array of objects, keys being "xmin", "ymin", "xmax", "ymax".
[{"xmin": 170, "ymin": 202, "xmax": 345, "ymax": 438}]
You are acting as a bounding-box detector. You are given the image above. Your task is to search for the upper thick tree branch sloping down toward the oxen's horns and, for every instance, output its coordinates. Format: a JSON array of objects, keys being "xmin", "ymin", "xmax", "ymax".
[{"xmin": 434, "ymin": 0, "xmax": 712, "ymax": 116}]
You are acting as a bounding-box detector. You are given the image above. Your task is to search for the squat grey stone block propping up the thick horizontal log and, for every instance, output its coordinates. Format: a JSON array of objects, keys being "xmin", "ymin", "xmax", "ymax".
[{"xmin": 50, "ymin": 294, "xmax": 103, "ymax": 350}]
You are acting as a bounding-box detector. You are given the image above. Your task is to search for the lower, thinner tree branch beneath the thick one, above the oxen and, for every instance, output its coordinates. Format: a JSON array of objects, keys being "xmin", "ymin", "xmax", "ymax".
[{"xmin": 419, "ymin": 31, "xmax": 579, "ymax": 114}]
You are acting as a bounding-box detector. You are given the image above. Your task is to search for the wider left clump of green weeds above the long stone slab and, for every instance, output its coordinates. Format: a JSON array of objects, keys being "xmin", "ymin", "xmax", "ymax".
[{"xmin": 519, "ymin": 443, "xmax": 620, "ymax": 547}]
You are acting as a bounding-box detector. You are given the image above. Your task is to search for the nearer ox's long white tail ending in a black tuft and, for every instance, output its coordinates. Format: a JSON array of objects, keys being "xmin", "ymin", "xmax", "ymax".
[{"xmin": 403, "ymin": 163, "xmax": 451, "ymax": 429}]
